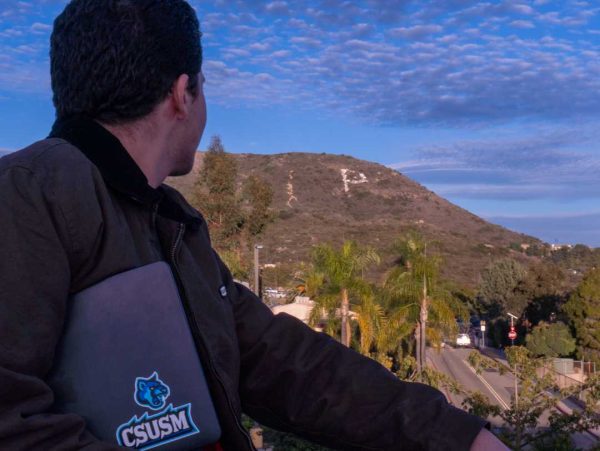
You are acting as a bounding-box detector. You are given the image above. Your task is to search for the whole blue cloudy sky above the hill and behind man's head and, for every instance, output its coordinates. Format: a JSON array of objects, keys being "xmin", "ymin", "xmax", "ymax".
[{"xmin": 0, "ymin": 0, "xmax": 600, "ymax": 246}]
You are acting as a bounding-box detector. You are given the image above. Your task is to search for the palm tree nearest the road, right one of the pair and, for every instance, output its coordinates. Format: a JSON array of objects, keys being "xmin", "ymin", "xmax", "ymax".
[{"xmin": 385, "ymin": 232, "xmax": 464, "ymax": 373}]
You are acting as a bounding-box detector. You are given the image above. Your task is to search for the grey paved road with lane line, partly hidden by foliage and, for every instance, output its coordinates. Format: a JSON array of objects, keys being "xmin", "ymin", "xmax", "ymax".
[{"xmin": 427, "ymin": 347, "xmax": 598, "ymax": 449}]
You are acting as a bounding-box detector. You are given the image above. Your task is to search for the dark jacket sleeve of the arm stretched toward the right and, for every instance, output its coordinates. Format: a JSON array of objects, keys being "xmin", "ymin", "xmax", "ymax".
[{"xmin": 216, "ymin": 256, "xmax": 486, "ymax": 451}]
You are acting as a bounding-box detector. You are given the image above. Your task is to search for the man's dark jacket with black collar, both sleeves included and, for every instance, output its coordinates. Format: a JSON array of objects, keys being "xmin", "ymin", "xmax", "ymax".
[{"xmin": 0, "ymin": 118, "xmax": 484, "ymax": 451}]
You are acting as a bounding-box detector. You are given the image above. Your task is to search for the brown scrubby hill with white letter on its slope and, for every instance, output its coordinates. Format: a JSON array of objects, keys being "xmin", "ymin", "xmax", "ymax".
[{"xmin": 168, "ymin": 153, "xmax": 540, "ymax": 287}]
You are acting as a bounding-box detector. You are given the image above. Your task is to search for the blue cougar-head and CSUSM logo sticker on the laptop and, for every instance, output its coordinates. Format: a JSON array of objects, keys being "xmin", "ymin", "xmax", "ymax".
[{"xmin": 117, "ymin": 371, "xmax": 199, "ymax": 450}]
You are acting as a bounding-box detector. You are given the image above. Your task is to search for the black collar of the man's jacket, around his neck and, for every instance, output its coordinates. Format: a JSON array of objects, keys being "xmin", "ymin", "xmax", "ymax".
[{"xmin": 48, "ymin": 116, "xmax": 201, "ymax": 228}]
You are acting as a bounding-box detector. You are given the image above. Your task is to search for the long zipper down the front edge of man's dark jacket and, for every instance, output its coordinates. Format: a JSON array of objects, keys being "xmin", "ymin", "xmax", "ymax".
[{"xmin": 170, "ymin": 223, "xmax": 256, "ymax": 450}]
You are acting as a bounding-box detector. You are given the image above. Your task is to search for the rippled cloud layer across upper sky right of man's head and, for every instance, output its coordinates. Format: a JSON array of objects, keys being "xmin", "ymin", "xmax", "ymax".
[{"xmin": 191, "ymin": 0, "xmax": 600, "ymax": 126}]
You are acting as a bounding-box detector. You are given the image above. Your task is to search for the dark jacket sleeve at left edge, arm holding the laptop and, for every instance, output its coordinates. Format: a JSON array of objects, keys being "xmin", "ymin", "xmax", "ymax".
[{"xmin": 0, "ymin": 167, "xmax": 118, "ymax": 451}]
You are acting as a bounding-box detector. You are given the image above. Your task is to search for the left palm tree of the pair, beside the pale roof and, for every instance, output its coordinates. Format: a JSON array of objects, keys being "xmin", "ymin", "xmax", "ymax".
[{"xmin": 306, "ymin": 241, "xmax": 380, "ymax": 346}]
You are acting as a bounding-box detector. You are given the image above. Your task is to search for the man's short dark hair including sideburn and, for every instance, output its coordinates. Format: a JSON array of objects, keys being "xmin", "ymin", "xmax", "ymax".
[{"xmin": 50, "ymin": 0, "xmax": 202, "ymax": 124}]
